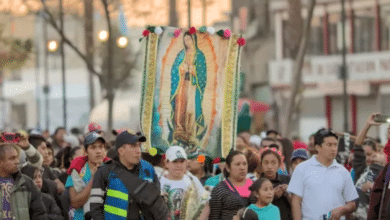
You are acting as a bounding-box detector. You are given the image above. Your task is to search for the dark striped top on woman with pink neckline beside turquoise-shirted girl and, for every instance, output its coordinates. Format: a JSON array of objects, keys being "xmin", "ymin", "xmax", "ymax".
[{"xmin": 209, "ymin": 179, "xmax": 256, "ymax": 220}]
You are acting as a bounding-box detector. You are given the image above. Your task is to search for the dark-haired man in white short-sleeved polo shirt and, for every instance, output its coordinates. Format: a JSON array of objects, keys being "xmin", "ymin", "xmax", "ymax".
[{"xmin": 287, "ymin": 129, "xmax": 358, "ymax": 220}]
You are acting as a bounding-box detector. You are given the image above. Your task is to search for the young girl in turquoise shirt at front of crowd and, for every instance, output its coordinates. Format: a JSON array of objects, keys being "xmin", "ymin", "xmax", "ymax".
[{"xmin": 248, "ymin": 178, "xmax": 280, "ymax": 220}]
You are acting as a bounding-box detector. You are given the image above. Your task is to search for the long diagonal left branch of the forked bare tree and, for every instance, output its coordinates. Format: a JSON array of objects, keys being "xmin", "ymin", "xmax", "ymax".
[{"xmin": 41, "ymin": 0, "xmax": 106, "ymax": 88}]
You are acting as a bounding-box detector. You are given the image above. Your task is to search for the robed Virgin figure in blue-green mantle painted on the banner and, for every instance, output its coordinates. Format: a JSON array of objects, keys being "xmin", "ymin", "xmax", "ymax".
[{"xmin": 169, "ymin": 32, "xmax": 207, "ymax": 149}]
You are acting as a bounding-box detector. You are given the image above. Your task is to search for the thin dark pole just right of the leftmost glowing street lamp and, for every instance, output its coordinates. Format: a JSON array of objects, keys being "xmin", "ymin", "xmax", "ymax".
[{"xmin": 60, "ymin": 0, "xmax": 67, "ymax": 129}]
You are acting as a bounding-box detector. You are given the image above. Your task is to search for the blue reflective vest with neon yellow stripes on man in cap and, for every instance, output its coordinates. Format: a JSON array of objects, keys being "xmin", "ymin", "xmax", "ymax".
[{"xmin": 104, "ymin": 160, "xmax": 154, "ymax": 220}]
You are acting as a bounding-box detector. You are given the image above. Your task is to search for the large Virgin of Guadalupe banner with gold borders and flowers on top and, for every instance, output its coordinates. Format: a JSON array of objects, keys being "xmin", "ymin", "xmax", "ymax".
[{"xmin": 140, "ymin": 27, "xmax": 245, "ymax": 158}]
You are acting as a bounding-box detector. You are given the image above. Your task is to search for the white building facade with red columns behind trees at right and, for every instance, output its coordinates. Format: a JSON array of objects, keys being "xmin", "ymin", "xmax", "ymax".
[{"xmin": 268, "ymin": 0, "xmax": 390, "ymax": 142}]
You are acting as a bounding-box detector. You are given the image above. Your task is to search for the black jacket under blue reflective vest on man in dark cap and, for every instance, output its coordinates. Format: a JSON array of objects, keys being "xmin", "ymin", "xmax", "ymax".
[{"xmin": 90, "ymin": 161, "xmax": 168, "ymax": 220}]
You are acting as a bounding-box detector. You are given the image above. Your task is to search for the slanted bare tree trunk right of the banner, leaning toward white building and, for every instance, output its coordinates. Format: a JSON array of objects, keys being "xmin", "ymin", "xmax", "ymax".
[{"xmin": 282, "ymin": 0, "xmax": 316, "ymax": 137}]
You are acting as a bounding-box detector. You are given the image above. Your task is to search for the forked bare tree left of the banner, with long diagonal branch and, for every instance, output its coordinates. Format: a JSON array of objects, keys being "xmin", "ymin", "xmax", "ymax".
[{"xmin": 41, "ymin": 0, "xmax": 139, "ymax": 130}]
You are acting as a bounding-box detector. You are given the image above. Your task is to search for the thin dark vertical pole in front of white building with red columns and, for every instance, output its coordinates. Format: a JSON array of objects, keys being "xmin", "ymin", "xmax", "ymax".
[{"xmin": 341, "ymin": 0, "xmax": 349, "ymax": 132}]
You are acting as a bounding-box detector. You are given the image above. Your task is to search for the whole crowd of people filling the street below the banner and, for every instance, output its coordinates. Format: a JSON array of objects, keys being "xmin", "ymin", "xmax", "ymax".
[{"xmin": 0, "ymin": 114, "xmax": 390, "ymax": 220}]
